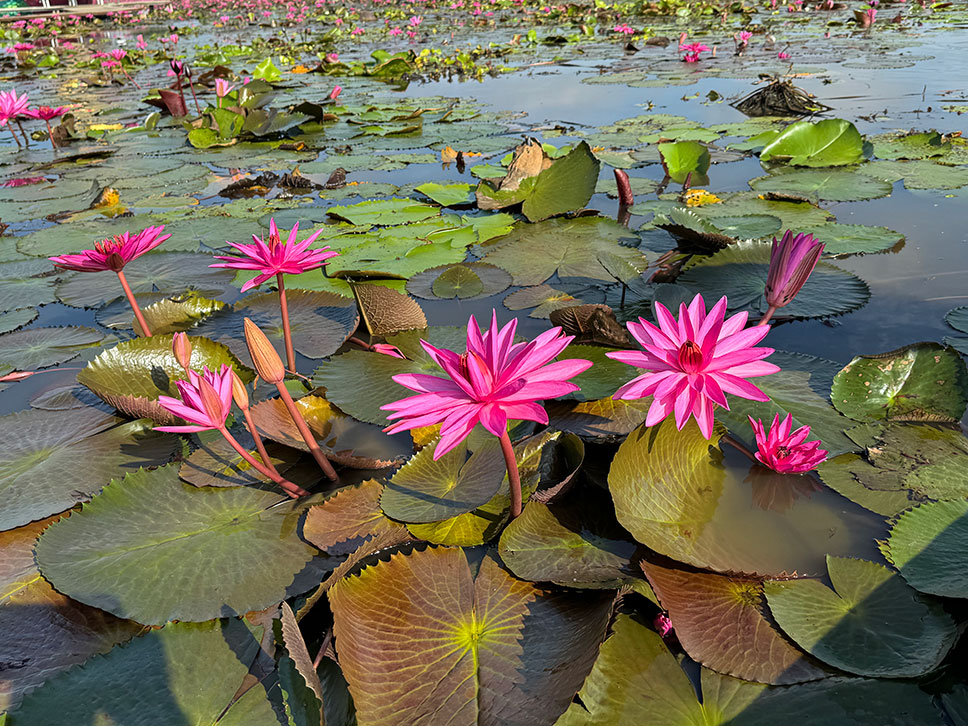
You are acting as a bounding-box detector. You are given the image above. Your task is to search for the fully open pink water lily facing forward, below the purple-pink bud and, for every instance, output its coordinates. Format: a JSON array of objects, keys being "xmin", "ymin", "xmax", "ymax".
[{"xmin": 606, "ymin": 295, "xmax": 780, "ymax": 439}]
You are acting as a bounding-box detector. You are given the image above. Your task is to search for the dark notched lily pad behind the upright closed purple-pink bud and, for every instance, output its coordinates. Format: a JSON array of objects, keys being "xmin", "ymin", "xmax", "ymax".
[{"xmin": 679, "ymin": 242, "xmax": 870, "ymax": 318}]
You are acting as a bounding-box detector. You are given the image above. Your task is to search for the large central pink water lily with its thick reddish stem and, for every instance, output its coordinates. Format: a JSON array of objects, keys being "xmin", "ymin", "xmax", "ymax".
[{"xmin": 381, "ymin": 312, "xmax": 592, "ymax": 517}]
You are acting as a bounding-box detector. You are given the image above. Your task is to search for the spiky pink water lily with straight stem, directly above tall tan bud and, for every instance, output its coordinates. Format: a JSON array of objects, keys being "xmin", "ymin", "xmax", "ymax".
[{"xmin": 210, "ymin": 219, "xmax": 339, "ymax": 373}]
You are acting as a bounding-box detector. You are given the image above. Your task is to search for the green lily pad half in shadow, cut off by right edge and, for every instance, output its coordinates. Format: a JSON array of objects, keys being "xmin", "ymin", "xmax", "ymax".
[{"xmin": 882, "ymin": 499, "xmax": 968, "ymax": 598}]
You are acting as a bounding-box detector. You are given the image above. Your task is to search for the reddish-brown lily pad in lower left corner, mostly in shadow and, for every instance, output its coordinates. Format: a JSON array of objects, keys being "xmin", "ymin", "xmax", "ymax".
[{"xmin": 0, "ymin": 520, "xmax": 141, "ymax": 711}]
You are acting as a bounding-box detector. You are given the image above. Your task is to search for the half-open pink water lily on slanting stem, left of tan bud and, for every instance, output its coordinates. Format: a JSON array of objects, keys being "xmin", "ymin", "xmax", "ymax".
[{"xmin": 155, "ymin": 365, "xmax": 309, "ymax": 498}]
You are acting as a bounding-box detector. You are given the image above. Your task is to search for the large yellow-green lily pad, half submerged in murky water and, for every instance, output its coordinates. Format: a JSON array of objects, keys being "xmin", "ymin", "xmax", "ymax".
[{"xmin": 608, "ymin": 419, "xmax": 880, "ymax": 574}]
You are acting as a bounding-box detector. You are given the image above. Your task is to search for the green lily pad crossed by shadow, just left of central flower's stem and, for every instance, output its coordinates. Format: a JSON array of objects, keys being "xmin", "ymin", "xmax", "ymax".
[{"xmin": 380, "ymin": 437, "xmax": 507, "ymax": 524}]
